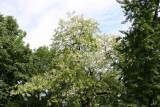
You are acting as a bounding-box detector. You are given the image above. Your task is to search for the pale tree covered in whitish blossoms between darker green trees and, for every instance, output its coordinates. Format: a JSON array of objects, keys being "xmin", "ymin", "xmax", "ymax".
[{"xmin": 12, "ymin": 13, "xmax": 123, "ymax": 107}]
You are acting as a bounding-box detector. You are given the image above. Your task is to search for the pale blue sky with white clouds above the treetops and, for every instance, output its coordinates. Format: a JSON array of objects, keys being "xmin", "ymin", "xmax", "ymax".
[{"xmin": 0, "ymin": 0, "xmax": 128, "ymax": 49}]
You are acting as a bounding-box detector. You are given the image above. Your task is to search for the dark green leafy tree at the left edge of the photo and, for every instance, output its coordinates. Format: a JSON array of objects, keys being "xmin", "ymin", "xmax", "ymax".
[{"xmin": 0, "ymin": 14, "xmax": 36, "ymax": 106}]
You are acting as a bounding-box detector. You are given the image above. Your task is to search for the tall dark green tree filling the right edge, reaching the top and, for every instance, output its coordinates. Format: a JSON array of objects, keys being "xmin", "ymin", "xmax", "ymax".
[{"xmin": 117, "ymin": 0, "xmax": 160, "ymax": 107}]
